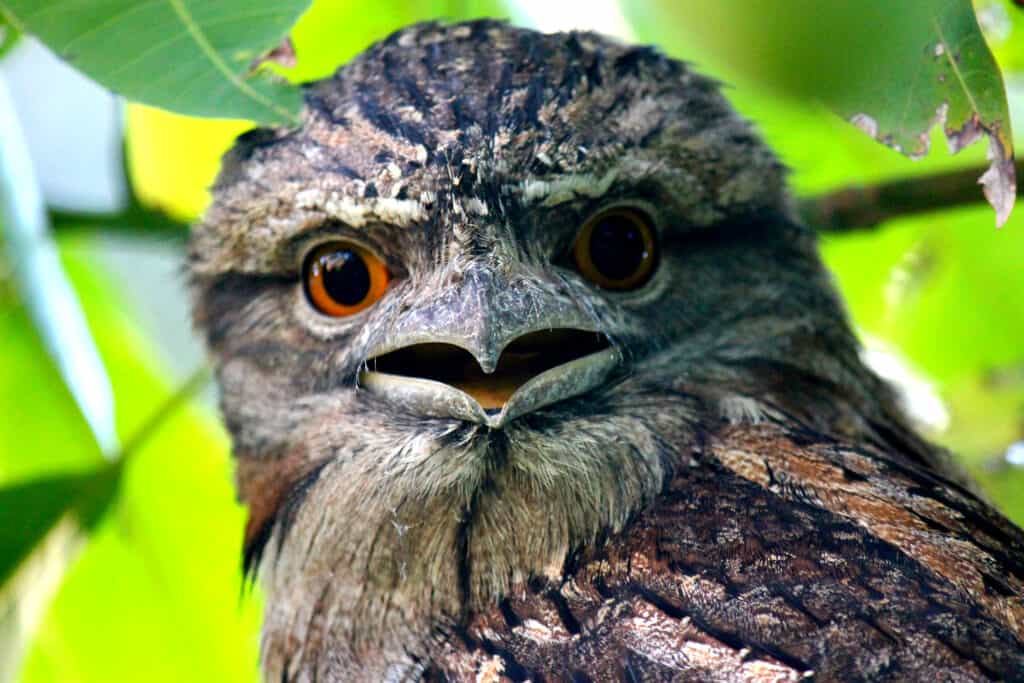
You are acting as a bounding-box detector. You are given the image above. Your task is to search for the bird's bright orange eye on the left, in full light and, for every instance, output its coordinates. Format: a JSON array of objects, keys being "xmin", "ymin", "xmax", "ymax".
[{"xmin": 302, "ymin": 242, "xmax": 390, "ymax": 317}]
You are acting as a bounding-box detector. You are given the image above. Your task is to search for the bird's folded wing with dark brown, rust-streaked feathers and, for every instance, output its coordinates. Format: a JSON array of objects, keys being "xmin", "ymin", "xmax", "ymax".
[{"xmin": 427, "ymin": 423, "xmax": 1024, "ymax": 681}]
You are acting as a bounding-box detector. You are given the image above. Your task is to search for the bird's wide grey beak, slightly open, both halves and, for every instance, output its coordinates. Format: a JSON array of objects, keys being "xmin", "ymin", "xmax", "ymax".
[{"xmin": 359, "ymin": 267, "xmax": 622, "ymax": 428}]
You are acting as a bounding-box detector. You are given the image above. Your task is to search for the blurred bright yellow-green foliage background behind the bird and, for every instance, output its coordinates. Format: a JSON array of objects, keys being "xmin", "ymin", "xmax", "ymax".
[{"xmin": 0, "ymin": 0, "xmax": 1024, "ymax": 682}]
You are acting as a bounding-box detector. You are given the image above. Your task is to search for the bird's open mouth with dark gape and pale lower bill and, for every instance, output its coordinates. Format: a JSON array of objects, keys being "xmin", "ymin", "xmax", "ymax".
[{"xmin": 359, "ymin": 329, "xmax": 618, "ymax": 426}]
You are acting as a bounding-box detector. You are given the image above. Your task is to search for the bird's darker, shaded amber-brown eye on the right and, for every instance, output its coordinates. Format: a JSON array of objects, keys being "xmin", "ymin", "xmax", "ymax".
[{"xmin": 572, "ymin": 207, "xmax": 657, "ymax": 290}]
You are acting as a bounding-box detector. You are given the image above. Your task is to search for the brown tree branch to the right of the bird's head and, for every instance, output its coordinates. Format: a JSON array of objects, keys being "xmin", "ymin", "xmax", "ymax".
[{"xmin": 799, "ymin": 161, "xmax": 1024, "ymax": 232}]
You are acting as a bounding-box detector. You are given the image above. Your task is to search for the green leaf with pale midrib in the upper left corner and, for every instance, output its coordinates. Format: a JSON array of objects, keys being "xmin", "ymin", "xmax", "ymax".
[{"xmin": 0, "ymin": 0, "xmax": 309, "ymax": 125}]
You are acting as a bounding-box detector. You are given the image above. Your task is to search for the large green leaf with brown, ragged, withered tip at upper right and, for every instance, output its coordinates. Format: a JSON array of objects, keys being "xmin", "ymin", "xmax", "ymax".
[{"xmin": 624, "ymin": 0, "xmax": 1015, "ymax": 224}]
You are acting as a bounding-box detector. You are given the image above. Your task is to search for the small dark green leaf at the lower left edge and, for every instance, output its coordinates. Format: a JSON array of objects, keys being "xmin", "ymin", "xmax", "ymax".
[{"xmin": 0, "ymin": 465, "xmax": 121, "ymax": 588}]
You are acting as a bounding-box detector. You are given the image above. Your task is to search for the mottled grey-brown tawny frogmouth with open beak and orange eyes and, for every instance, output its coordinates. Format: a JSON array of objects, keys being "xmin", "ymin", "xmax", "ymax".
[{"xmin": 186, "ymin": 19, "xmax": 1024, "ymax": 681}]
